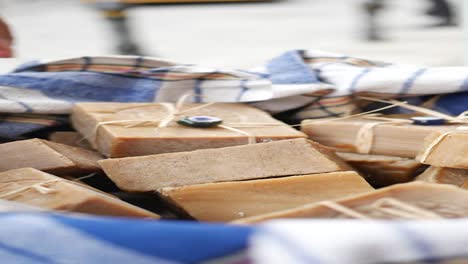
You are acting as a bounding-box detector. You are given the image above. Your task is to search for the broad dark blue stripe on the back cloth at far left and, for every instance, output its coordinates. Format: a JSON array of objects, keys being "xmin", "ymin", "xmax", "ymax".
[{"xmin": 0, "ymin": 71, "xmax": 162, "ymax": 103}]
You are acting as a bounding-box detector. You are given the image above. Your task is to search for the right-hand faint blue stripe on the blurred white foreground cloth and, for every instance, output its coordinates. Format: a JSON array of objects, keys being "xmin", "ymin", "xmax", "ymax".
[{"xmin": 390, "ymin": 222, "xmax": 438, "ymax": 263}]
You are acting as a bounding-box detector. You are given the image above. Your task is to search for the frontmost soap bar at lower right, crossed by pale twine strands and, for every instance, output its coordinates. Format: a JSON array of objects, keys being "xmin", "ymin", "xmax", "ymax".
[{"xmin": 235, "ymin": 182, "xmax": 468, "ymax": 223}]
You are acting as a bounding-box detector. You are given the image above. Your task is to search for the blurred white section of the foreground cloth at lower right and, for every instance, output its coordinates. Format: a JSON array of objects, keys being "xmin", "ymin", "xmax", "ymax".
[{"xmin": 249, "ymin": 219, "xmax": 468, "ymax": 264}]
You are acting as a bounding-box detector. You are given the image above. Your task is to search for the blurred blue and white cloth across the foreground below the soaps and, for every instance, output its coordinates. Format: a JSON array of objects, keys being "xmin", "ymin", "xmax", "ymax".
[{"xmin": 0, "ymin": 213, "xmax": 468, "ymax": 264}]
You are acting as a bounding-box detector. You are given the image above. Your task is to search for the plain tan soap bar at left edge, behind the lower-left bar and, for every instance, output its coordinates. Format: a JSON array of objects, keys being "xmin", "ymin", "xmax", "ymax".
[{"xmin": 0, "ymin": 138, "xmax": 102, "ymax": 175}]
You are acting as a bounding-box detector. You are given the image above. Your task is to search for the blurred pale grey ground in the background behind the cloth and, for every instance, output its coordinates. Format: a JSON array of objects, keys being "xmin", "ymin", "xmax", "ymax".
[{"xmin": 0, "ymin": 0, "xmax": 464, "ymax": 68}]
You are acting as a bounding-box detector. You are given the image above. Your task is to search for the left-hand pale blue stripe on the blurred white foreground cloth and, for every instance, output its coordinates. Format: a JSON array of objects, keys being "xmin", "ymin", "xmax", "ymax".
[{"xmin": 256, "ymin": 227, "xmax": 323, "ymax": 264}]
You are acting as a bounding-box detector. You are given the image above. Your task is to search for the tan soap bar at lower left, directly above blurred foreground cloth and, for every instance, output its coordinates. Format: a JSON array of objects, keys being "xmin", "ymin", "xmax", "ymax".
[{"xmin": 0, "ymin": 168, "xmax": 159, "ymax": 218}]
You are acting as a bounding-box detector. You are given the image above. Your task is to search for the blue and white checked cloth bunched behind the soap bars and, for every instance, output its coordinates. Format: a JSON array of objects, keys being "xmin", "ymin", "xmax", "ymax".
[{"xmin": 0, "ymin": 50, "xmax": 468, "ymax": 139}]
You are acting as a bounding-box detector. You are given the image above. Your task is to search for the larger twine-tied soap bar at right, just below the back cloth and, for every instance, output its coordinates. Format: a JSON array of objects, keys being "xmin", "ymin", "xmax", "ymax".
[{"xmin": 301, "ymin": 118, "xmax": 454, "ymax": 159}]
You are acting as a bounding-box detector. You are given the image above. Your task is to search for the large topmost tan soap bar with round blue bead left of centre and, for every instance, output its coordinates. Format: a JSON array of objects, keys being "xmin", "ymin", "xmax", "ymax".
[{"xmin": 71, "ymin": 103, "xmax": 306, "ymax": 157}]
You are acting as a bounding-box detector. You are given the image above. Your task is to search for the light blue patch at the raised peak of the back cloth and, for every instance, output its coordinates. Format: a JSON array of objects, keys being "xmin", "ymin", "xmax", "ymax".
[{"xmin": 267, "ymin": 51, "xmax": 319, "ymax": 84}]
